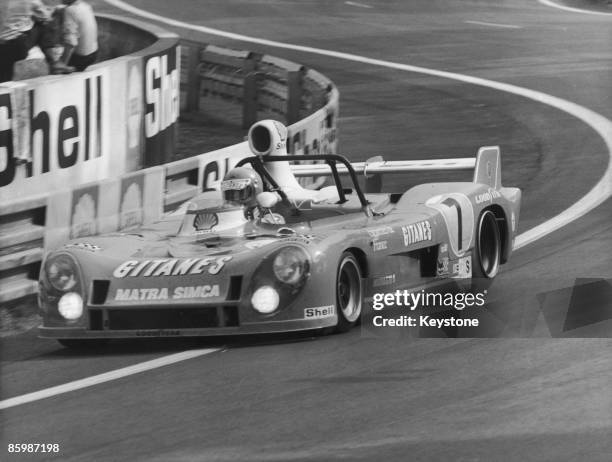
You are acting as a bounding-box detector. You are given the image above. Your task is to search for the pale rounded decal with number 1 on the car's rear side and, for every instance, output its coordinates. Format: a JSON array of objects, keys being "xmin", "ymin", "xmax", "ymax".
[{"xmin": 425, "ymin": 193, "xmax": 474, "ymax": 255}]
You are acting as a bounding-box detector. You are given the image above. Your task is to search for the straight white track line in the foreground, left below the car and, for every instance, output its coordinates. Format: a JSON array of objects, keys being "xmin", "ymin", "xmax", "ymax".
[{"xmin": 0, "ymin": 348, "xmax": 220, "ymax": 409}]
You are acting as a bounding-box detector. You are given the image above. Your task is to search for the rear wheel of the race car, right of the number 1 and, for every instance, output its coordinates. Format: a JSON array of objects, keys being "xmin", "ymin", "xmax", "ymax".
[{"xmin": 472, "ymin": 210, "xmax": 502, "ymax": 291}]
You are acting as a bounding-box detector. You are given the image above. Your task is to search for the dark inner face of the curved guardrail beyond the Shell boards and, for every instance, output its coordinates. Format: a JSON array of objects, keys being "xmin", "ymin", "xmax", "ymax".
[{"xmin": 181, "ymin": 40, "xmax": 333, "ymax": 128}]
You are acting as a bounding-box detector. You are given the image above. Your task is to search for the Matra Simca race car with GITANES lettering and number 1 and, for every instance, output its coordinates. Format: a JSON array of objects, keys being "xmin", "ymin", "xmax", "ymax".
[{"xmin": 39, "ymin": 120, "xmax": 521, "ymax": 346}]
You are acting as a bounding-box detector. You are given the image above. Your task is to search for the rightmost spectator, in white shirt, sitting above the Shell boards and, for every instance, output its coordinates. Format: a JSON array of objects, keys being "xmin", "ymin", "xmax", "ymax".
[{"xmin": 61, "ymin": 0, "xmax": 98, "ymax": 72}]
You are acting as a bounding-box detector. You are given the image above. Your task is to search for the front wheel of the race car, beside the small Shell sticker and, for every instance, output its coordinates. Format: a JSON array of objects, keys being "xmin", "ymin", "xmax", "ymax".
[{"xmin": 335, "ymin": 252, "xmax": 363, "ymax": 332}]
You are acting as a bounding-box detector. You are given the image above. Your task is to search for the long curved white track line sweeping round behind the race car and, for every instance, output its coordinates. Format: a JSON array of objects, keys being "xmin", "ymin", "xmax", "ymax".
[{"xmin": 105, "ymin": 0, "xmax": 612, "ymax": 249}]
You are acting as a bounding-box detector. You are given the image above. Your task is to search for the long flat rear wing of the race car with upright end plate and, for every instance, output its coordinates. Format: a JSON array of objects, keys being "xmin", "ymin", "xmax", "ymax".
[{"xmin": 291, "ymin": 146, "xmax": 501, "ymax": 190}]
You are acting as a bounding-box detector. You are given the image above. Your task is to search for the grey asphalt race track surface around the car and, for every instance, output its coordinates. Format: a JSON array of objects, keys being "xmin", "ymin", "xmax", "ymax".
[{"xmin": 0, "ymin": 0, "xmax": 612, "ymax": 461}]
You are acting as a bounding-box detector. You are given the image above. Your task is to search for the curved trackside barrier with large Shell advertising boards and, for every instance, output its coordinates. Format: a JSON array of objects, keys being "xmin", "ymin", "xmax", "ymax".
[{"xmin": 0, "ymin": 16, "xmax": 339, "ymax": 303}]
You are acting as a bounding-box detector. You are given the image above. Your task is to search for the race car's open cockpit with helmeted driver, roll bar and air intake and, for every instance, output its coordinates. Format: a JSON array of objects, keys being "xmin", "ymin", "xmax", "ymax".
[{"xmin": 170, "ymin": 120, "xmax": 393, "ymax": 236}]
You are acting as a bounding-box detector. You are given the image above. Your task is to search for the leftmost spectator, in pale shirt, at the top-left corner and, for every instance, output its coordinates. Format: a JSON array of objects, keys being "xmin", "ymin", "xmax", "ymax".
[{"xmin": 0, "ymin": 0, "xmax": 74, "ymax": 82}]
